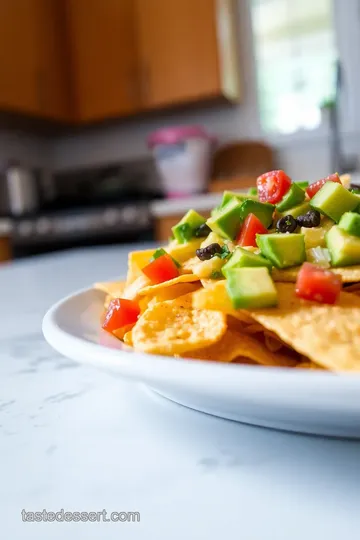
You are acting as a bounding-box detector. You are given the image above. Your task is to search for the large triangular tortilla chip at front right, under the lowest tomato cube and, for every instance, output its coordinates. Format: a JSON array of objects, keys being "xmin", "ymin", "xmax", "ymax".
[{"xmin": 251, "ymin": 283, "xmax": 360, "ymax": 371}]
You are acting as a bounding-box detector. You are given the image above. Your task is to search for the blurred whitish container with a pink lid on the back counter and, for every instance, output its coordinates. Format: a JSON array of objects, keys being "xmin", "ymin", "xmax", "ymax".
[{"xmin": 147, "ymin": 125, "xmax": 216, "ymax": 198}]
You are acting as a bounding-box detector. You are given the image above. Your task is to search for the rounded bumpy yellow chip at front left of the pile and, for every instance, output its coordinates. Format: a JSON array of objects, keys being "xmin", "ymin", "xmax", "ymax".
[{"xmin": 132, "ymin": 300, "xmax": 226, "ymax": 355}]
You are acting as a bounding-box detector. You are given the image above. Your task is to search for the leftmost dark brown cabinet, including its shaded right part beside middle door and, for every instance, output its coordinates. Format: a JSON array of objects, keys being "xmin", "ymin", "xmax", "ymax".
[{"xmin": 0, "ymin": 0, "xmax": 70, "ymax": 120}]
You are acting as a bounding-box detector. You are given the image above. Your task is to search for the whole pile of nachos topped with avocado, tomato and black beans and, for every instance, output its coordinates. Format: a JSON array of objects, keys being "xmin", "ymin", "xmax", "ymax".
[{"xmin": 95, "ymin": 170, "xmax": 360, "ymax": 372}]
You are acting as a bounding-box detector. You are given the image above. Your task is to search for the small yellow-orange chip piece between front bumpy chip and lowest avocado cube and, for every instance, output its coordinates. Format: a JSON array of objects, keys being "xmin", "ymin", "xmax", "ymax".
[{"xmin": 193, "ymin": 280, "xmax": 253, "ymax": 323}]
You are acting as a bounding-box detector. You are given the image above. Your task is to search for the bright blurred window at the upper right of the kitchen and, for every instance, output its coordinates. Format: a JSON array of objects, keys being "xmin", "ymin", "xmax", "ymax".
[{"xmin": 250, "ymin": 0, "xmax": 337, "ymax": 134}]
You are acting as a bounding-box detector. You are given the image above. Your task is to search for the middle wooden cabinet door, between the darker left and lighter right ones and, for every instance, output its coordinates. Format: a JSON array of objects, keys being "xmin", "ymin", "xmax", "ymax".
[{"xmin": 67, "ymin": 0, "xmax": 139, "ymax": 121}]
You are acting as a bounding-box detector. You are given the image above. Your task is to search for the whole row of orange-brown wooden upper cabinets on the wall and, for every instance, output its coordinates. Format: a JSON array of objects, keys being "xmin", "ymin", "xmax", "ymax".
[{"xmin": 0, "ymin": 0, "xmax": 240, "ymax": 124}]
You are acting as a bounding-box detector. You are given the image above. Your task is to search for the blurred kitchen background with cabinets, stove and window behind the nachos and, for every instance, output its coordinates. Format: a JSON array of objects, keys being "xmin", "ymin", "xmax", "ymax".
[{"xmin": 0, "ymin": 0, "xmax": 360, "ymax": 261}]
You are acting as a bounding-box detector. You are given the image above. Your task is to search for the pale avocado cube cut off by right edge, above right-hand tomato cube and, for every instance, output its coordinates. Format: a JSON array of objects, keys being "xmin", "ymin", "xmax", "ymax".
[{"xmin": 325, "ymin": 225, "xmax": 360, "ymax": 266}]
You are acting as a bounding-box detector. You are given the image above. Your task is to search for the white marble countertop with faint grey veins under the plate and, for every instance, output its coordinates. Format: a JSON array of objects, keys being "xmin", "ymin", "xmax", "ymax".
[{"xmin": 0, "ymin": 248, "xmax": 360, "ymax": 540}]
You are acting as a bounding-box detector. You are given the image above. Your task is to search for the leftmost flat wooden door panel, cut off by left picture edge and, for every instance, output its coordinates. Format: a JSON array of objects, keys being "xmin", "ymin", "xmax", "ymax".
[{"xmin": 0, "ymin": 0, "xmax": 41, "ymax": 115}]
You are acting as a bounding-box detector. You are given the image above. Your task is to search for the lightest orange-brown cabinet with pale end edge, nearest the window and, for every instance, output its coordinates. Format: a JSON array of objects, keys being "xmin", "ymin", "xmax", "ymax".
[{"xmin": 135, "ymin": 0, "xmax": 240, "ymax": 109}]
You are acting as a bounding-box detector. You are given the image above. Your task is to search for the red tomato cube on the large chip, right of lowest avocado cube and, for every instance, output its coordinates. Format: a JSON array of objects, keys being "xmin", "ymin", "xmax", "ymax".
[{"xmin": 296, "ymin": 263, "xmax": 341, "ymax": 304}]
